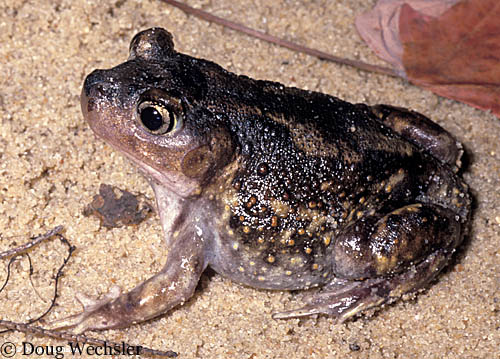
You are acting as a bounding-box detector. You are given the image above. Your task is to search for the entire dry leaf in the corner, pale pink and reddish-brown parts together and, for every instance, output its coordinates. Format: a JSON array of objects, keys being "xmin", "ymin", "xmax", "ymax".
[{"xmin": 356, "ymin": 0, "xmax": 500, "ymax": 116}]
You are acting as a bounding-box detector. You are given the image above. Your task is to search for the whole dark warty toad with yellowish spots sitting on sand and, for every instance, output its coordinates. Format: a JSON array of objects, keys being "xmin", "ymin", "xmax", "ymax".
[{"xmin": 59, "ymin": 28, "xmax": 471, "ymax": 332}]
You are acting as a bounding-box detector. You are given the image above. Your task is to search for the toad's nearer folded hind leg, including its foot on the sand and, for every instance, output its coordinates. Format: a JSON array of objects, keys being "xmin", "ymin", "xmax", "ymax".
[{"xmin": 273, "ymin": 204, "xmax": 463, "ymax": 322}]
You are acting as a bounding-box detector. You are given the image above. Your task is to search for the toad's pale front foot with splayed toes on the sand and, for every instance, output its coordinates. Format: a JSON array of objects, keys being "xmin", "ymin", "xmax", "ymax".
[{"xmin": 49, "ymin": 286, "xmax": 126, "ymax": 333}]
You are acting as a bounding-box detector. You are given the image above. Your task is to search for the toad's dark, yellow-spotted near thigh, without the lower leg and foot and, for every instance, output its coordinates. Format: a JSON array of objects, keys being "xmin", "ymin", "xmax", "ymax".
[{"xmin": 333, "ymin": 203, "xmax": 462, "ymax": 279}]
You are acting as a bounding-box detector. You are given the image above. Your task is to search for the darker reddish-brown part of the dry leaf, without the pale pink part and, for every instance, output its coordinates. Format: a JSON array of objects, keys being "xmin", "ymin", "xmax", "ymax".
[{"xmin": 399, "ymin": 0, "xmax": 500, "ymax": 116}]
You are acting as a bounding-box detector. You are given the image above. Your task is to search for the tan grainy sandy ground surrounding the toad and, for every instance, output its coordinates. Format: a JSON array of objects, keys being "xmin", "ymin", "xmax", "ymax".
[{"xmin": 0, "ymin": 0, "xmax": 500, "ymax": 358}]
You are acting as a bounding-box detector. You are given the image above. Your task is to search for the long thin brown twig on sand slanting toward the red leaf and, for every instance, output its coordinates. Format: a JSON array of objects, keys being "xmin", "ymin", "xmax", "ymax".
[{"xmin": 161, "ymin": 0, "xmax": 400, "ymax": 77}]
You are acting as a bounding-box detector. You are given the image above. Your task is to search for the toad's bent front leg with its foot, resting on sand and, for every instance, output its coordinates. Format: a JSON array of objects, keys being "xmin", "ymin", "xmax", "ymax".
[{"xmin": 51, "ymin": 229, "xmax": 206, "ymax": 333}]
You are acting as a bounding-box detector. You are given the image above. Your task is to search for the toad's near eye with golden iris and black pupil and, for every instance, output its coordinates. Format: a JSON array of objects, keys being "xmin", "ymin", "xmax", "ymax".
[{"xmin": 137, "ymin": 101, "xmax": 179, "ymax": 135}]
